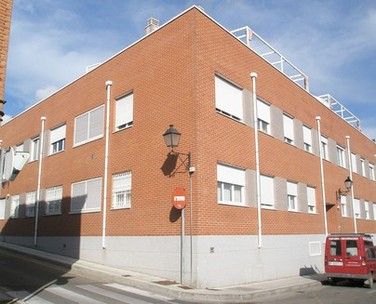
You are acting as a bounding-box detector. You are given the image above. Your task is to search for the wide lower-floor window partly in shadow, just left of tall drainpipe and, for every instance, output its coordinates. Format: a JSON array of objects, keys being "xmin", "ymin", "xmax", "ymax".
[{"xmin": 71, "ymin": 177, "xmax": 102, "ymax": 213}]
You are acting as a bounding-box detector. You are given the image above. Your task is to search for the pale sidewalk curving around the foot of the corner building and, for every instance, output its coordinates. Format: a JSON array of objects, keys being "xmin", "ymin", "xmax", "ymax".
[{"xmin": 0, "ymin": 242, "xmax": 322, "ymax": 303}]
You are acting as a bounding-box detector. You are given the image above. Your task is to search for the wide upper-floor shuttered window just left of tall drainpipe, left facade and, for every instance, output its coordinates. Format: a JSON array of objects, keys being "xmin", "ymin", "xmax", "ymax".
[{"xmin": 74, "ymin": 106, "xmax": 104, "ymax": 145}]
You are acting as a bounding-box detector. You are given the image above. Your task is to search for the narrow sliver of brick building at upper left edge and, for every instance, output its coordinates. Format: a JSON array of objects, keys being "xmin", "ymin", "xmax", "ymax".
[{"xmin": 0, "ymin": 0, "xmax": 12, "ymax": 120}]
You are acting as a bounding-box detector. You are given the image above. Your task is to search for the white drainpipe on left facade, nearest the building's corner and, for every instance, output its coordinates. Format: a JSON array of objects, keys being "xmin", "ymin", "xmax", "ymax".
[{"xmin": 102, "ymin": 80, "xmax": 112, "ymax": 249}]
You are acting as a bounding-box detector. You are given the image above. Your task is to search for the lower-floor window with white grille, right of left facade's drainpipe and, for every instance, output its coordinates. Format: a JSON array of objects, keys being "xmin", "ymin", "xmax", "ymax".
[{"xmin": 112, "ymin": 172, "xmax": 132, "ymax": 209}]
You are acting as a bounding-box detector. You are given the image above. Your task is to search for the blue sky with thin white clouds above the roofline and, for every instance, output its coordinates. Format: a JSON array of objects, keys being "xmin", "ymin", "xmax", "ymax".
[{"xmin": 5, "ymin": 0, "xmax": 376, "ymax": 138}]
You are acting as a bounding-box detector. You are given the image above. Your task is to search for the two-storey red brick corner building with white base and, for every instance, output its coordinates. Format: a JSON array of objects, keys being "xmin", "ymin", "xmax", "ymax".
[{"xmin": 0, "ymin": 7, "xmax": 376, "ymax": 287}]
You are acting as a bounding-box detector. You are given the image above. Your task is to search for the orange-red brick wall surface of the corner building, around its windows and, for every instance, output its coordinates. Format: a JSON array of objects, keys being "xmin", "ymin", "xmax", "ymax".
[{"xmin": 0, "ymin": 9, "xmax": 376, "ymax": 235}]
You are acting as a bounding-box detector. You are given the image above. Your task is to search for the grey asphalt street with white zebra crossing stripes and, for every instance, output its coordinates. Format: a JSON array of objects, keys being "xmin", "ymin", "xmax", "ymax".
[{"xmin": 0, "ymin": 249, "xmax": 376, "ymax": 304}]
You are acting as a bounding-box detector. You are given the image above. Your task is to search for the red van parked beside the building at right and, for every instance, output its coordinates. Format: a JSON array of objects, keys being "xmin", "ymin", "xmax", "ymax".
[{"xmin": 325, "ymin": 233, "xmax": 376, "ymax": 288}]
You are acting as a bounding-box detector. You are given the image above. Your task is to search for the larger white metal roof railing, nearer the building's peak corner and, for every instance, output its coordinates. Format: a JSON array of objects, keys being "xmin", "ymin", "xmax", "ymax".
[{"xmin": 231, "ymin": 26, "xmax": 309, "ymax": 91}]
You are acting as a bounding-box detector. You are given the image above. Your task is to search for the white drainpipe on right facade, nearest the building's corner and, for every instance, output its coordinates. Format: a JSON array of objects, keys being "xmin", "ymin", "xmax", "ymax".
[{"xmin": 250, "ymin": 72, "xmax": 262, "ymax": 248}]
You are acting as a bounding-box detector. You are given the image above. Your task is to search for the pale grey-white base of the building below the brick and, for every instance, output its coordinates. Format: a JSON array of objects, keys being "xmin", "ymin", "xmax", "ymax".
[{"xmin": 3, "ymin": 235, "xmax": 348, "ymax": 288}]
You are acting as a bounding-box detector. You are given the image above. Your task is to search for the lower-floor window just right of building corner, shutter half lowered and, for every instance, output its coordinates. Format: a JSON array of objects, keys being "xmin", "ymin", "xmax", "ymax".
[{"xmin": 217, "ymin": 165, "xmax": 245, "ymax": 206}]
